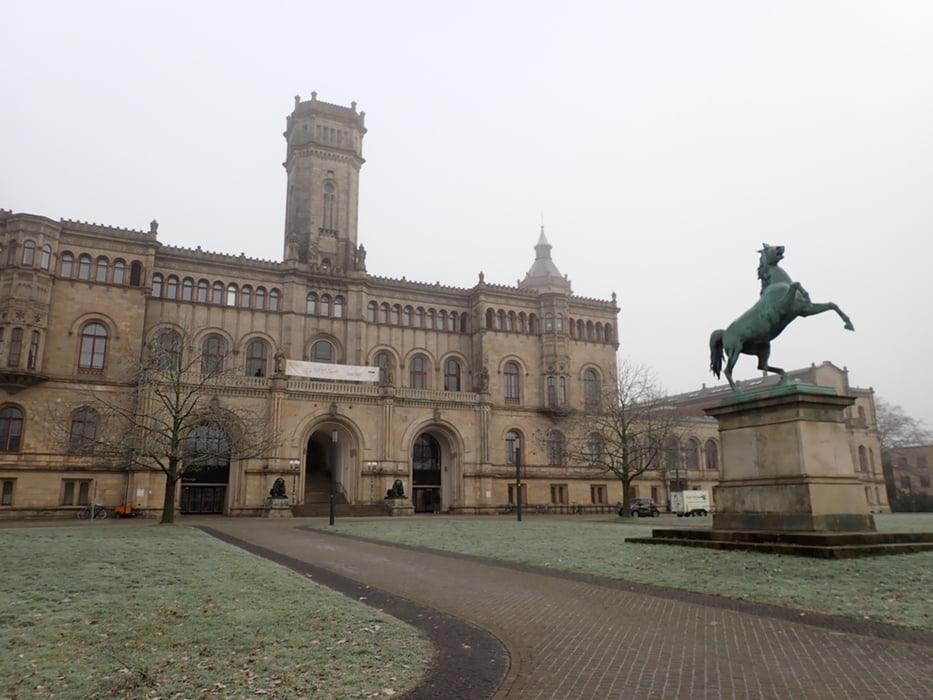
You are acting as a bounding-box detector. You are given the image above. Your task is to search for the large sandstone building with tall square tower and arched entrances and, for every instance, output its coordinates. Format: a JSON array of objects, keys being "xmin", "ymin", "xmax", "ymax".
[{"xmin": 0, "ymin": 95, "xmax": 621, "ymax": 517}]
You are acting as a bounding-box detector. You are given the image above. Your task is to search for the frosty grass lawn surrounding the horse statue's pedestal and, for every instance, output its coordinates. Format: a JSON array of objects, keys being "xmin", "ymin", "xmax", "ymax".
[{"xmin": 321, "ymin": 513, "xmax": 933, "ymax": 630}]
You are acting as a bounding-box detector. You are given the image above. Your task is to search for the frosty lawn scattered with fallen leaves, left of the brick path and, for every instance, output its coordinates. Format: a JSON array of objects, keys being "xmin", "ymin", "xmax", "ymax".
[{"xmin": 0, "ymin": 525, "xmax": 432, "ymax": 700}]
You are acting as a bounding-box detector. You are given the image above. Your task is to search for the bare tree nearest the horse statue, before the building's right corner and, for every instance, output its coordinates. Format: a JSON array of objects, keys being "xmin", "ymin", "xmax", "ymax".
[{"xmin": 564, "ymin": 360, "xmax": 680, "ymax": 517}]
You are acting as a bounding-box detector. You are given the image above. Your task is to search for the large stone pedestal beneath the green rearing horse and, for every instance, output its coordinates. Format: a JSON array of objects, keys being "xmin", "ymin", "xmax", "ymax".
[{"xmin": 706, "ymin": 384, "xmax": 875, "ymax": 532}]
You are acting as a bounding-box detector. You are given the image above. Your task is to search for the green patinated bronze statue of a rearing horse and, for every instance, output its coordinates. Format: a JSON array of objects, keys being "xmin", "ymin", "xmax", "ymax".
[{"xmin": 709, "ymin": 243, "xmax": 855, "ymax": 391}]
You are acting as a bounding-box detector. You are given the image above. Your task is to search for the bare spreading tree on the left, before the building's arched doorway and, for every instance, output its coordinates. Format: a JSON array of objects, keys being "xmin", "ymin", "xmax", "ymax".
[{"xmin": 61, "ymin": 330, "xmax": 275, "ymax": 523}]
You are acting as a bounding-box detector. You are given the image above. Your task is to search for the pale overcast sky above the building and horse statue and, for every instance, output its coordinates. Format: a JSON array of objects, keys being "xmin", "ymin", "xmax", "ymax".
[{"xmin": 0, "ymin": 0, "xmax": 933, "ymax": 425}]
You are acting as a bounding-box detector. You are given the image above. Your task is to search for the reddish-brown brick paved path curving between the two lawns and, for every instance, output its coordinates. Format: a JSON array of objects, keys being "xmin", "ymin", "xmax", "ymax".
[{"xmin": 197, "ymin": 518, "xmax": 933, "ymax": 700}]
